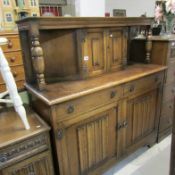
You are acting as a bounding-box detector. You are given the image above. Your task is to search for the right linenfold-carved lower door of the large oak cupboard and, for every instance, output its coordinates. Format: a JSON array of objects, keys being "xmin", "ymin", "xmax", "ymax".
[{"xmin": 126, "ymin": 90, "xmax": 158, "ymax": 147}]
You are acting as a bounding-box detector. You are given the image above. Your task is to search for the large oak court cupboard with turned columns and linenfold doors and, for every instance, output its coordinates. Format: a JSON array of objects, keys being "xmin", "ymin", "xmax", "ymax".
[{"xmin": 18, "ymin": 17, "xmax": 166, "ymax": 175}]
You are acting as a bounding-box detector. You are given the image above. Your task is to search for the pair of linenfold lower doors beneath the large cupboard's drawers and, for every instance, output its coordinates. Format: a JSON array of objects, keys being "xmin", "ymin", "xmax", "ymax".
[{"xmin": 57, "ymin": 88, "xmax": 160, "ymax": 175}]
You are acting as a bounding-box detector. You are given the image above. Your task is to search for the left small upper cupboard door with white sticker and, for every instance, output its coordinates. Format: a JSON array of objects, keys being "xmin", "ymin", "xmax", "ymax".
[{"xmin": 78, "ymin": 28, "xmax": 106, "ymax": 76}]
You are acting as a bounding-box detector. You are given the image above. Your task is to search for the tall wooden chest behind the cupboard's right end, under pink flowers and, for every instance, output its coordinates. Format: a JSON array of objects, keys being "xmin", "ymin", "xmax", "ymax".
[{"xmin": 130, "ymin": 35, "xmax": 175, "ymax": 141}]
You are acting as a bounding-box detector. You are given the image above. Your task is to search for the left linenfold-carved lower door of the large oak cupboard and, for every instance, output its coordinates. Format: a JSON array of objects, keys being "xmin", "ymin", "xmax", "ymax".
[{"xmin": 61, "ymin": 107, "xmax": 118, "ymax": 175}]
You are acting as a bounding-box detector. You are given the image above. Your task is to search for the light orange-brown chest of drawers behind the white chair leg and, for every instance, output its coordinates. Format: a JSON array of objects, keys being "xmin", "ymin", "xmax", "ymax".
[{"xmin": 0, "ymin": 31, "xmax": 25, "ymax": 92}]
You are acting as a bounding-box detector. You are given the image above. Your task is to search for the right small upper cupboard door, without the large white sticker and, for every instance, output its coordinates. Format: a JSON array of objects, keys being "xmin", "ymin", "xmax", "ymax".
[{"xmin": 107, "ymin": 28, "xmax": 127, "ymax": 71}]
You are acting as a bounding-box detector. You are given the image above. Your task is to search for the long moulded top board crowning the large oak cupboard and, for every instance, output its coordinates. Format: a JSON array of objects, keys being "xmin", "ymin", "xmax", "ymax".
[{"xmin": 17, "ymin": 17, "xmax": 153, "ymax": 30}]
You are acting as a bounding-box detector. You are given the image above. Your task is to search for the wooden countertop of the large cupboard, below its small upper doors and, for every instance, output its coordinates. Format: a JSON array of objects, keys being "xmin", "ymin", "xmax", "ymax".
[{"xmin": 26, "ymin": 64, "xmax": 167, "ymax": 105}]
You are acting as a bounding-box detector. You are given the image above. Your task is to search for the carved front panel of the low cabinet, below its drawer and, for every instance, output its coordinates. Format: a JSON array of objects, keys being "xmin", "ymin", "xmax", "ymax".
[{"xmin": 2, "ymin": 152, "xmax": 54, "ymax": 175}]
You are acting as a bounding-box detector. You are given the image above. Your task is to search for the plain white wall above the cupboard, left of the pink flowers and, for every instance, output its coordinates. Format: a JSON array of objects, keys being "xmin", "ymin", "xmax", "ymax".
[{"xmin": 105, "ymin": 0, "xmax": 155, "ymax": 17}]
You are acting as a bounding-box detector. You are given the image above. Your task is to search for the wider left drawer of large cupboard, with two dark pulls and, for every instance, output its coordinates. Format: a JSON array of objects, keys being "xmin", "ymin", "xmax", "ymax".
[{"xmin": 56, "ymin": 86, "xmax": 123, "ymax": 120}]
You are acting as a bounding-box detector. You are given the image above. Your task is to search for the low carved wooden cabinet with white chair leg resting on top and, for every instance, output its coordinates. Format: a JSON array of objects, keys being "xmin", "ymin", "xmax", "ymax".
[{"xmin": 0, "ymin": 107, "xmax": 54, "ymax": 175}]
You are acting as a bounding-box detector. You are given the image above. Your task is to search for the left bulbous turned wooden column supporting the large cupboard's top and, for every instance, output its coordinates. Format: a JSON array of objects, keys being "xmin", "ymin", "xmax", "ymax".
[{"xmin": 30, "ymin": 22, "xmax": 46, "ymax": 90}]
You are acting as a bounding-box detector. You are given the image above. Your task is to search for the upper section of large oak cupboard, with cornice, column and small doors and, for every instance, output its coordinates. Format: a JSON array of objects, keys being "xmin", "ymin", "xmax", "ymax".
[{"xmin": 17, "ymin": 17, "xmax": 152, "ymax": 90}]
